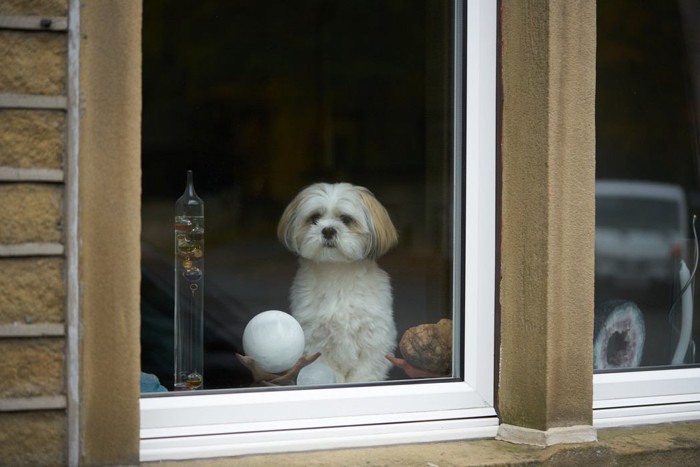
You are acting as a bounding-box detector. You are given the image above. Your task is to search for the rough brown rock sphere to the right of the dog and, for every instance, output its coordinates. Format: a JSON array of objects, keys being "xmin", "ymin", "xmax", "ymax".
[{"xmin": 399, "ymin": 319, "xmax": 452, "ymax": 375}]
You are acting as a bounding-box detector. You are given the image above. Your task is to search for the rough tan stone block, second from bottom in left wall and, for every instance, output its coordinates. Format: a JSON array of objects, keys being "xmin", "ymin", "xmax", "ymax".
[{"xmin": 0, "ymin": 337, "xmax": 65, "ymax": 398}]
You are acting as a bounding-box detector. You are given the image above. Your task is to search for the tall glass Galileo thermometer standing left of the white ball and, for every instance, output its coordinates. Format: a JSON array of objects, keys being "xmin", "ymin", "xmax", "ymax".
[{"xmin": 174, "ymin": 170, "xmax": 204, "ymax": 391}]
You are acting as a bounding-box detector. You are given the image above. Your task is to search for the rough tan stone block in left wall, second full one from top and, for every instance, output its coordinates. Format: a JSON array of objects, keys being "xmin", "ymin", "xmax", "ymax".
[{"xmin": 0, "ymin": 110, "xmax": 66, "ymax": 169}]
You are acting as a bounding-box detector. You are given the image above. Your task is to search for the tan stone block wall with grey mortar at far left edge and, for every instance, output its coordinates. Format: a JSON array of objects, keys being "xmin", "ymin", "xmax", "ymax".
[{"xmin": 0, "ymin": 0, "xmax": 68, "ymax": 465}]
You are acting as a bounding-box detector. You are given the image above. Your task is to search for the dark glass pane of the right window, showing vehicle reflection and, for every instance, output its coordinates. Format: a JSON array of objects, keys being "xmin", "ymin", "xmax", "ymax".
[{"xmin": 594, "ymin": 0, "xmax": 700, "ymax": 371}]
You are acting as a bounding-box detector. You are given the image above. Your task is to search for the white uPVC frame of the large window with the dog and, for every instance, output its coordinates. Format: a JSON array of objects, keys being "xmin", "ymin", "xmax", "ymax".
[{"xmin": 141, "ymin": 0, "xmax": 498, "ymax": 461}]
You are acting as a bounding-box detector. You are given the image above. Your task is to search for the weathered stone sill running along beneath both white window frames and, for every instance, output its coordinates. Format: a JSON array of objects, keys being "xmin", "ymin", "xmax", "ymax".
[{"xmin": 148, "ymin": 422, "xmax": 700, "ymax": 467}]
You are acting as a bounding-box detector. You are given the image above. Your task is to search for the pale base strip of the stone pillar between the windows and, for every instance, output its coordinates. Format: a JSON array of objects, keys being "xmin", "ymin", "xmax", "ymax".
[{"xmin": 496, "ymin": 423, "xmax": 598, "ymax": 447}]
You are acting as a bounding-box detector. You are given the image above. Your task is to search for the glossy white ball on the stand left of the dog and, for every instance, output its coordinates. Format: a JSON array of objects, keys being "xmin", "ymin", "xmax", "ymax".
[{"xmin": 243, "ymin": 310, "xmax": 305, "ymax": 373}]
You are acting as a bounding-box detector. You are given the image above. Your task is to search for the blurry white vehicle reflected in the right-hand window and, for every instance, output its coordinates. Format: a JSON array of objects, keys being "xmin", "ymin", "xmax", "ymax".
[{"xmin": 595, "ymin": 180, "xmax": 688, "ymax": 286}]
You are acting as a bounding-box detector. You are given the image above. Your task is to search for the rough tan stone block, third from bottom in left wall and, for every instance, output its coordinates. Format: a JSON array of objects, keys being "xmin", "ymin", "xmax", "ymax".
[{"xmin": 0, "ymin": 258, "xmax": 65, "ymax": 324}]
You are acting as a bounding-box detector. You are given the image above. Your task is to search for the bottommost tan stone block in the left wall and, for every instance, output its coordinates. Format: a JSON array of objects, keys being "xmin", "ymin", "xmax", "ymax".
[{"xmin": 0, "ymin": 411, "xmax": 68, "ymax": 465}]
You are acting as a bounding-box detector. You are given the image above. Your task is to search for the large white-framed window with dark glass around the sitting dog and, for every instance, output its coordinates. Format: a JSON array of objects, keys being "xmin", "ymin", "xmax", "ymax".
[{"xmin": 141, "ymin": 0, "xmax": 498, "ymax": 460}]
